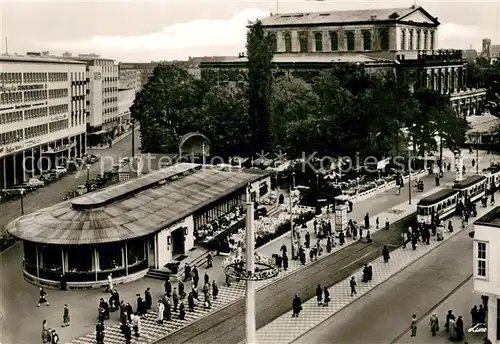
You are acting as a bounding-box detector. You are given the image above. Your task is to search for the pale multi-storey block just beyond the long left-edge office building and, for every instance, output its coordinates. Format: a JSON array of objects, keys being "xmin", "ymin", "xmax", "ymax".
[{"xmin": 68, "ymin": 54, "xmax": 121, "ymax": 146}]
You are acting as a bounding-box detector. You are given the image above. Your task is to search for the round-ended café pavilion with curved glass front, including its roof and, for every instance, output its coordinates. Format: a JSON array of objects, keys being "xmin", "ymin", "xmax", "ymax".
[{"xmin": 7, "ymin": 163, "xmax": 270, "ymax": 288}]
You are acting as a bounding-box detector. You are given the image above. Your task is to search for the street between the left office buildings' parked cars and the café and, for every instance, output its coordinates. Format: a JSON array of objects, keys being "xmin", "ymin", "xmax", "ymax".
[{"xmin": 0, "ymin": 131, "xmax": 140, "ymax": 230}]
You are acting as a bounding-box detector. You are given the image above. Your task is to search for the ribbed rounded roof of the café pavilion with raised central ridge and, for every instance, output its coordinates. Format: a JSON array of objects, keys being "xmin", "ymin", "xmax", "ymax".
[{"xmin": 7, "ymin": 163, "xmax": 268, "ymax": 245}]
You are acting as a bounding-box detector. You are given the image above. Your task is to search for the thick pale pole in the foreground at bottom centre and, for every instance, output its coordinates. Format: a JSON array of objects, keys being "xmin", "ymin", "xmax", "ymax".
[{"xmin": 245, "ymin": 199, "xmax": 257, "ymax": 344}]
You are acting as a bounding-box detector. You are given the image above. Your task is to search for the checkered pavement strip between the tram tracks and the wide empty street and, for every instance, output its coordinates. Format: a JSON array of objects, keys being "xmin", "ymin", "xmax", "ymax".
[{"xmin": 243, "ymin": 200, "xmax": 491, "ymax": 344}]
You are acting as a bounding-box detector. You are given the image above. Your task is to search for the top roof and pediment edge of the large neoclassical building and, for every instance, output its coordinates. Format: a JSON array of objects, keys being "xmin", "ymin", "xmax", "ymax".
[{"xmin": 261, "ymin": 6, "xmax": 439, "ymax": 26}]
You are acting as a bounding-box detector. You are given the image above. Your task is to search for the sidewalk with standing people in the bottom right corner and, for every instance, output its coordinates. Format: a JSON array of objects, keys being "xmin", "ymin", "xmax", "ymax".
[{"xmin": 394, "ymin": 278, "xmax": 485, "ymax": 344}]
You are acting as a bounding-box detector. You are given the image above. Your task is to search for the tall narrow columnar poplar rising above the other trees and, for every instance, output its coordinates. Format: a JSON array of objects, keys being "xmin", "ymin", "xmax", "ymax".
[{"xmin": 246, "ymin": 20, "xmax": 273, "ymax": 155}]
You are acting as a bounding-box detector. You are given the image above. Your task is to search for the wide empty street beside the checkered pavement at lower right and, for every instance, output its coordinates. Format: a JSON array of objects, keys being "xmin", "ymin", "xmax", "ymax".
[{"xmin": 295, "ymin": 226, "xmax": 473, "ymax": 344}]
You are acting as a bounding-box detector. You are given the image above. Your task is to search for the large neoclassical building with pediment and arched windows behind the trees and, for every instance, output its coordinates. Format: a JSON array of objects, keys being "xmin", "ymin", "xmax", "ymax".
[{"xmin": 201, "ymin": 6, "xmax": 486, "ymax": 116}]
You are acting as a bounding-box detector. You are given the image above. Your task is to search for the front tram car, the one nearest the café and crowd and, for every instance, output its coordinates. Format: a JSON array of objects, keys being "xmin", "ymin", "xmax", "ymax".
[{"xmin": 417, "ymin": 189, "xmax": 460, "ymax": 225}]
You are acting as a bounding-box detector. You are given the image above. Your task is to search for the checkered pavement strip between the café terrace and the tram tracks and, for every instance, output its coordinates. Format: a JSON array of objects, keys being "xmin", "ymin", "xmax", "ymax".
[{"xmin": 67, "ymin": 190, "xmax": 436, "ymax": 344}]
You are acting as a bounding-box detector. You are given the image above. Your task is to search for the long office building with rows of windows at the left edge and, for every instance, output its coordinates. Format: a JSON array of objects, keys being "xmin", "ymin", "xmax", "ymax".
[{"xmin": 0, "ymin": 53, "xmax": 87, "ymax": 189}]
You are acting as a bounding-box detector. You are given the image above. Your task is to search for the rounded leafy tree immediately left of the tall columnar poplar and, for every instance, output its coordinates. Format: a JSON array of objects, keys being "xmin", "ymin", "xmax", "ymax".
[{"xmin": 201, "ymin": 84, "xmax": 250, "ymax": 158}]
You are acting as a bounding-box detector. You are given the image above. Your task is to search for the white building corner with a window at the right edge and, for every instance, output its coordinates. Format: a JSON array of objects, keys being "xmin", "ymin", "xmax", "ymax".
[{"xmin": 473, "ymin": 207, "xmax": 500, "ymax": 343}]
